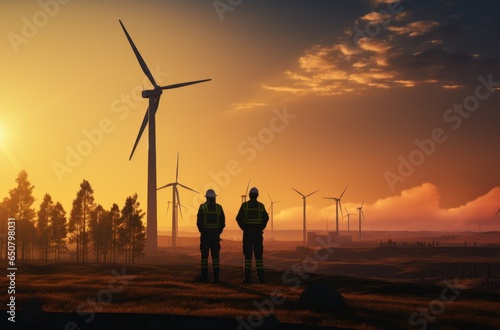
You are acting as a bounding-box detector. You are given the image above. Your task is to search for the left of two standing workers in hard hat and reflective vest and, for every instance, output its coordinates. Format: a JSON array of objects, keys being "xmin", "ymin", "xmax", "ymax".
[{"xmin": 196, "ymin": 189, "xmax": 226, "ymax": 283}]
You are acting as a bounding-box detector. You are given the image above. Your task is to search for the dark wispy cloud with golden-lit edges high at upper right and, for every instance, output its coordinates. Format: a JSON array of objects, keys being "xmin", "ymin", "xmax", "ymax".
[{"xmin": 262, "ymin": 0, "xmax": 500, "ymax": 95}]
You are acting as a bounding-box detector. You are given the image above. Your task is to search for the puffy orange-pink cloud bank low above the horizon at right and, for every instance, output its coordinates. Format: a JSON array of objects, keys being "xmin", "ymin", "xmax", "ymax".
[{"xmin": 274, "ymin": 183, "xmax": 500, "ymax": 232}]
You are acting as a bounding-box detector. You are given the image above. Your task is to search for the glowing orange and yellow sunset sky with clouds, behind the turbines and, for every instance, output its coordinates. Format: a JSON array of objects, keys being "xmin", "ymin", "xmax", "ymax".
[{"xmin": 0, "ymin": 0, "xmax": 500, "ymax": 235}]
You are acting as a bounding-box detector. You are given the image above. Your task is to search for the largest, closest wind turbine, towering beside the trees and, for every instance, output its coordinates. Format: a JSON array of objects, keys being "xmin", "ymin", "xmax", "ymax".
[{"xmin": 119, "ymin": 20, "xmax": 212, "ymax": 252}]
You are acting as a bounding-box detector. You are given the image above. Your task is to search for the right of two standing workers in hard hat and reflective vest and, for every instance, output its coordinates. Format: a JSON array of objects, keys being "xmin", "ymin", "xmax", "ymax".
[{"xmin": 236, "ymin": 187, "xmax": 269, "ymax": 283}]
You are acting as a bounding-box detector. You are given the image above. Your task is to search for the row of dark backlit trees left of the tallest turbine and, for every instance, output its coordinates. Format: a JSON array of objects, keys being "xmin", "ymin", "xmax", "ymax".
[{"xmin": 0, "ymin": 170, "xmax": 146, "ymax": 263}]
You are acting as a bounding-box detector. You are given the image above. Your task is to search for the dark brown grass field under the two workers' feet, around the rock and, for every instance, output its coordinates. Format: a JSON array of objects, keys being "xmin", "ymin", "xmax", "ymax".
[{"xmin": 2, "ymin": 238, "xmax": 500, "ymax": 329}]
